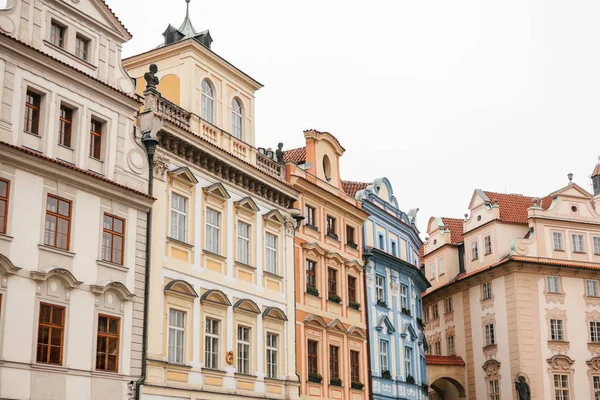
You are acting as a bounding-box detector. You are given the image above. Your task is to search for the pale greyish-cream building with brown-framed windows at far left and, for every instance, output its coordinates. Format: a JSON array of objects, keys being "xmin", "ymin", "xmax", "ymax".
[{"xmin": 0, "ymin": 0, "xmax": 153, "ymax": 400}]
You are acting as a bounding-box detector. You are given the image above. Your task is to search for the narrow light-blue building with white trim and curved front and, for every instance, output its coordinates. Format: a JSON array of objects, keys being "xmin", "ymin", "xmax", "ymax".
[{"xmin": 346, "ymin": 178, "xmax": 429, "ymax": 400}]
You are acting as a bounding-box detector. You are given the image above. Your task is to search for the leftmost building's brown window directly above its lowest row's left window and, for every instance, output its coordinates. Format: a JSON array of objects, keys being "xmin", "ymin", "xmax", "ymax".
[{"xmin": 44, "ymin": 194, "xmax": 71, "ymax": 250}]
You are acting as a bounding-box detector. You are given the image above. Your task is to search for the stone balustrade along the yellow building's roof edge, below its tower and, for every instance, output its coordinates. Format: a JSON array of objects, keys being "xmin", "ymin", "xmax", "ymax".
[{"xmin": 144, "ymin": 90, "xmax": 285, "ymax": 180}]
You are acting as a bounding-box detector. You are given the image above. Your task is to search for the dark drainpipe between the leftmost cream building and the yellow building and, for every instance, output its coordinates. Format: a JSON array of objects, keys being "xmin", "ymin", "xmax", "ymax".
[{"xmin": 135, "ymin": 129, "xmax": 158, "ymax": 400}]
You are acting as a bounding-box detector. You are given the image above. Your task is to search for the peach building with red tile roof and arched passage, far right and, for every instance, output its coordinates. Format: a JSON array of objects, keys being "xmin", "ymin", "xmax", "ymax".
[{"xmin": 423, "ymin": 167, "xmax": 600, "ymax": 400}]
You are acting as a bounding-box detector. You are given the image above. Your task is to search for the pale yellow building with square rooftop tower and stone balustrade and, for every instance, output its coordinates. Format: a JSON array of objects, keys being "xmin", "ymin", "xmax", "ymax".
[{"xmin": 124, "ymin": 4, "xmax": 299, "ymax": 399}]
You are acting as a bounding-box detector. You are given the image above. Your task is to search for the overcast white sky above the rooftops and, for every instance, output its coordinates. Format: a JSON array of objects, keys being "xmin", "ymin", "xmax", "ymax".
[{"xmin": 107, "ymin": 0, "xmax": 600, "ymax": 232}]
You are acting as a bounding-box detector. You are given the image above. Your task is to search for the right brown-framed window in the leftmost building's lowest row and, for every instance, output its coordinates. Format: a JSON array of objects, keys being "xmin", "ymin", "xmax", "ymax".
[{"xmin": 96, "ymin": 315, "xmax": 121, "ymax": 372}]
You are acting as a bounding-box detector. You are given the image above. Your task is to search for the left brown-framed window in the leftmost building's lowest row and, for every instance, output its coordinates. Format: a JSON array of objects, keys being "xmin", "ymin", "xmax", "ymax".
[{"xmin": 36, "ymin": 303, "xmax": 65, "ymax": 365}]
